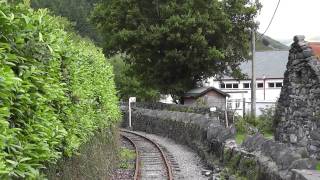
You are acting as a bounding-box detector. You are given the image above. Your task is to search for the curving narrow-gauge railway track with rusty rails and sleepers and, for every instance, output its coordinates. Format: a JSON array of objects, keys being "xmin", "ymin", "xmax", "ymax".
[{"xmin": 120, "ymin": 129, "xmax": 173, "ymax": 180}]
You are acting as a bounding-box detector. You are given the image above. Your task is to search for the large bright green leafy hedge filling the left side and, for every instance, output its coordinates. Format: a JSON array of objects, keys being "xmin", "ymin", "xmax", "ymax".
[{"xmin": 0, "ymin": 0, "xmax": 120, "ymax": 179}]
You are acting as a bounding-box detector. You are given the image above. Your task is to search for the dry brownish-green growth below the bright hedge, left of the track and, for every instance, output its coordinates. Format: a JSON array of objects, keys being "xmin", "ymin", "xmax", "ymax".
[{"xmin": 44, "ymin": 126, "xmax": 118, "ymax": 180}]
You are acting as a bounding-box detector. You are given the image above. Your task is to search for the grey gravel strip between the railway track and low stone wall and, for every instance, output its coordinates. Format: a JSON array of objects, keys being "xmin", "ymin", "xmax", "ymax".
[{"xmin": 133, "ymin": 132, "xmax": 209, "ymax": 180}]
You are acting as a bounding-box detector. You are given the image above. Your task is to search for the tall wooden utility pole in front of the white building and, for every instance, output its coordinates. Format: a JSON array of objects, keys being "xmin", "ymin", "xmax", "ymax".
[{"xmin": 251, "ymin": 19, "xmax": 257, "ymax": 117}]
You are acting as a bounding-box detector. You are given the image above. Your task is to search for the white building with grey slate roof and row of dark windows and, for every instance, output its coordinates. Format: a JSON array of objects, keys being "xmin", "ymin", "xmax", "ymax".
[{"xmin": 205, "ymin": 51, "xmax": 289, "ymax": 116}]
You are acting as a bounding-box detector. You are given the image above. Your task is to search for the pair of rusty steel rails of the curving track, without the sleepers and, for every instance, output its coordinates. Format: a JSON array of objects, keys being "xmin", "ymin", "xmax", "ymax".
[{"xmin": 120, "ymin": 129, "xmax": 173, "ymax": 180}]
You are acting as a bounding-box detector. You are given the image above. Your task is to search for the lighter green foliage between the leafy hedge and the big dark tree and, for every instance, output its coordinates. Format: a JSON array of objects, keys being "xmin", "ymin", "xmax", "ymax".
[{"xmin": 110, "ymin": 55, "xmax": 160, "ymax": 102}]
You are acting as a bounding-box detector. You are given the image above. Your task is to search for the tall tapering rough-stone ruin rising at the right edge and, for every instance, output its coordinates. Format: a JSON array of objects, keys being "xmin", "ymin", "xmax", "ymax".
[{"xmin": 275, "ymin": 36, "xmax": 320, "ymax": 159}]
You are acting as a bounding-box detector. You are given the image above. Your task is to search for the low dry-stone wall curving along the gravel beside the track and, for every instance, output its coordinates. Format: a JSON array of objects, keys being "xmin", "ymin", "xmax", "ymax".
[{"xmin": 124, "ymin": 108, "xmax": 316, "ymax": 180}]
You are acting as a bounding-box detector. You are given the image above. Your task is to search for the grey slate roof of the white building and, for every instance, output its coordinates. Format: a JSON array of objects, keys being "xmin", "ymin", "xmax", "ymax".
[{"xmin": 223, "ymin": 51, "xmax": 289, "ymax": 79}]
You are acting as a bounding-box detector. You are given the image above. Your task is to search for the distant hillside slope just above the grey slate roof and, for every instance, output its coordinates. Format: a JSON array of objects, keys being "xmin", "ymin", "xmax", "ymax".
[{"xmin": 256, "ymin": 33, "xmax": 289, "ymax": 51}]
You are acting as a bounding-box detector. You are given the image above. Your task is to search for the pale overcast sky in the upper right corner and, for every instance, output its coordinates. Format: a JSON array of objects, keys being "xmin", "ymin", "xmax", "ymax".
[{"xmin": 256, "ymin": 0, "xmax": 320, "ymax": 44}]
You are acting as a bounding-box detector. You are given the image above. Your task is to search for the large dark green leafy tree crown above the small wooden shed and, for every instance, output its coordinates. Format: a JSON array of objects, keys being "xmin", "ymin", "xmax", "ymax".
[{"xmin": 92, "ymin": 0, "xmax": 258, "ymax": 100}]
